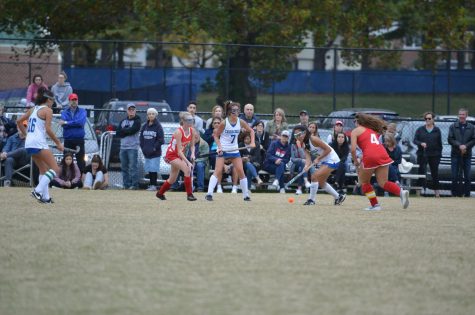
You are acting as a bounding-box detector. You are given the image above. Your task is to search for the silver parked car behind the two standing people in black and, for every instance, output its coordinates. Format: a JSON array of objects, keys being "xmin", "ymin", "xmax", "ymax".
[{"xmin": 398, "ymin": 121, "xmax": 475, "ymax": 186}]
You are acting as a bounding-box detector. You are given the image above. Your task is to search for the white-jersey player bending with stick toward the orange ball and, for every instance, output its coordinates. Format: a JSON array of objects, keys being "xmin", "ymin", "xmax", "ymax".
[{"xmin": 293, "ymin": 126, "xmax": 346, "ymax": 206}]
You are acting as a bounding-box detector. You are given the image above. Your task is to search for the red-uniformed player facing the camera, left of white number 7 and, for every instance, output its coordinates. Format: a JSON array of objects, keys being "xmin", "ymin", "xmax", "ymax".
[{"xmin": 157, "ymin": 112, "xmax": 196, "ymax": 201}]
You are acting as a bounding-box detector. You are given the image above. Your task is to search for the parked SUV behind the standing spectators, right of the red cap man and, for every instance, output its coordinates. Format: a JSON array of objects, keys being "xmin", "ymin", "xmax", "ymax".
[{"xmin": 95, "ymin": 99, "xmax": 176, "ymax": 167}]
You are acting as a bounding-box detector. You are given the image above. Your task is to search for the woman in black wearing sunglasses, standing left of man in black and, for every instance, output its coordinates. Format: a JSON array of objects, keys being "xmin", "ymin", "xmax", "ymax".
[{"xmin": 414, "ymin": 112, "xmax": 442, "ymax": 197}]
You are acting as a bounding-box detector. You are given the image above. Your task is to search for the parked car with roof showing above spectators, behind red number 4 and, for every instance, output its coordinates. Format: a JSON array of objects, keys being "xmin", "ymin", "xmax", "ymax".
[{"xmin": 319, "ymin": 108, "xmax": 399, "ymax": 133}]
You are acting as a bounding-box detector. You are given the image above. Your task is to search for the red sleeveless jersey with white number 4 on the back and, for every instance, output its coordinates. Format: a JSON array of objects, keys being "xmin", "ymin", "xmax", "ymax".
[{"xmin": 356, "ymin": 128, "xmax": 393, "ymax": 169}]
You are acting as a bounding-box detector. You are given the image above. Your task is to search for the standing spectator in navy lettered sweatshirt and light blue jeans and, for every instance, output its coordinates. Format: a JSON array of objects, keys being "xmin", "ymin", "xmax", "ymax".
[{"xmin": 140, "ymin": 107, "xmax": 165, "ymax": 191}]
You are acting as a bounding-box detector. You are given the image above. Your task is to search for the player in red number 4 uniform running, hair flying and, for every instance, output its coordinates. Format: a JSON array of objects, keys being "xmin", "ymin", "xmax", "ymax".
[{"xmin": 351, "ymin": 113, "xmax": 409, "ymax": 210}]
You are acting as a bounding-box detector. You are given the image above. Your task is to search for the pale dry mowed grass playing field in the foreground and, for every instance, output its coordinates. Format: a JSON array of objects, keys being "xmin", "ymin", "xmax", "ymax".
[{"xmin": 0, "ymin": 188, "xmax": 475, "ymax": 315}]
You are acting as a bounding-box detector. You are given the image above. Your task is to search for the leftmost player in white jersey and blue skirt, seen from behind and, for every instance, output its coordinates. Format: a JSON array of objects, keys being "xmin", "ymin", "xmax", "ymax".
[{"xmin": 17, "ymin": 91, "xmax": 64, "ymax": 203}]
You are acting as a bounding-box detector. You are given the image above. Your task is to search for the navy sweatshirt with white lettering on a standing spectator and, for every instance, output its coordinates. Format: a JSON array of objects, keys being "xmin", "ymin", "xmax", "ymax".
[{"xmin": 139, "ymin": 119, "xmax": 165, "ymax": 159}]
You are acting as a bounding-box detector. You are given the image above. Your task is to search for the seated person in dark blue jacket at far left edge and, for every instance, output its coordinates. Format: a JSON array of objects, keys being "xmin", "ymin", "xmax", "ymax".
[{"xmin": 0, "ymin": 132, "xmax": 31, "ymax": 187}]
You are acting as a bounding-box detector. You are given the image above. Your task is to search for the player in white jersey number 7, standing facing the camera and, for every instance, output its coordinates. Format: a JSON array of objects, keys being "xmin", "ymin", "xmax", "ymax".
[{"xmin": 206, "ymin": 101, "xmax": 256, "ymax": 201}]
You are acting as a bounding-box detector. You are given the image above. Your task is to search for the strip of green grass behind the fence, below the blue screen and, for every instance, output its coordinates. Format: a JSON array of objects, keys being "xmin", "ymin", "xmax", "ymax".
[{"xmin": 198, "ymin": 93, "xmax": 475, "ymax": 117}]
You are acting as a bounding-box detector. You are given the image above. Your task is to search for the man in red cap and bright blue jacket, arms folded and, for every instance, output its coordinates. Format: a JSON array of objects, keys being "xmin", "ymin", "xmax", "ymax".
[{"xmin": 58, "ymin": 93, "xmax": 87, "ymax": 172}]
